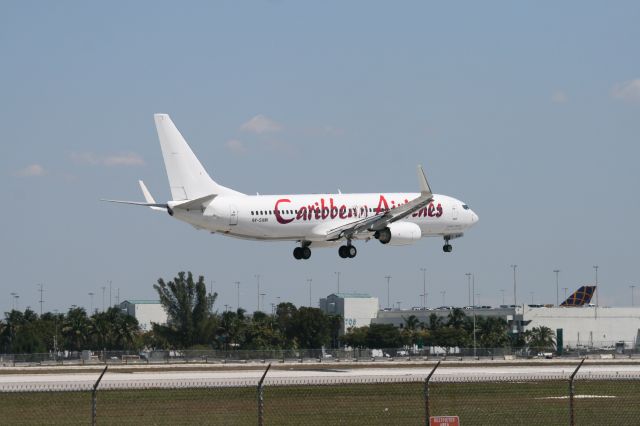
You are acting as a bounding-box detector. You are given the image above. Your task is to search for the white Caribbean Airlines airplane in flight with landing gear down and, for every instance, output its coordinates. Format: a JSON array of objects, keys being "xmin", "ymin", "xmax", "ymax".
[{"xmin": 102, "ymin": 114, "xmax": 478, "ymax": 259}]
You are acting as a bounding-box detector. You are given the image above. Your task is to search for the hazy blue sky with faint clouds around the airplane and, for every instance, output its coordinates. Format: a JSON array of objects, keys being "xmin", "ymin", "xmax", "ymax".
[{"xmin": 0, "ymin": 1, "xmax": 640, "ymax": 310}]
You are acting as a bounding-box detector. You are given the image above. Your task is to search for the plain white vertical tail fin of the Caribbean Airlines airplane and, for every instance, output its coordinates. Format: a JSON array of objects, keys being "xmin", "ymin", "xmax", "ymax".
[{"xmin": 154, "ymin": 114, "xmax": 239, "ymax": 201}]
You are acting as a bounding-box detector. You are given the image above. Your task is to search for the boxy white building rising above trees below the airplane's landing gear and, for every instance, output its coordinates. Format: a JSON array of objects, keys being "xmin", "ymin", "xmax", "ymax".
[{"xmin": 320, "ymin": 293, "xmax": 378, "ymax": 334}]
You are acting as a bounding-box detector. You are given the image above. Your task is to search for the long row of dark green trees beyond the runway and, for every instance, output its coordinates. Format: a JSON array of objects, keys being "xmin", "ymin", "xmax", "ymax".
[{"xmin": 0, "ymin": 272, "xmax": 555, "ymax": 353}]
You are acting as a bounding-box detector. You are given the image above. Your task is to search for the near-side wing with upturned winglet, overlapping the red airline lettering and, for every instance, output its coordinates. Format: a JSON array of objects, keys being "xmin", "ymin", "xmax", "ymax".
[{"xmin": 326, "ymin": 166, "xmax": 433, "ymax": 241}]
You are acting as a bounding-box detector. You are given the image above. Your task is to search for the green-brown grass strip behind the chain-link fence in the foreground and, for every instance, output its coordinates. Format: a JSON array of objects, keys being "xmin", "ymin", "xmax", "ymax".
[{"xmin": 0, "ymin": 380, "xmax": 640, "ymax": 425}]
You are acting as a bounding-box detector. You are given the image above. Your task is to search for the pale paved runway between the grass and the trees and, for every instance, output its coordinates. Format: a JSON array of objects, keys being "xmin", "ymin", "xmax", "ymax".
[{"xmin": 0, "ymin": 364, "xmax": 640, "ymax": 391}]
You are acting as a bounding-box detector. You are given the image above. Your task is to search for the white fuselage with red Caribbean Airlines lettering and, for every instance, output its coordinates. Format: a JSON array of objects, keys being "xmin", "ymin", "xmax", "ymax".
[{"xmin": 170, "ymin": 193, "xmax": 477, "ymax": 246}]
